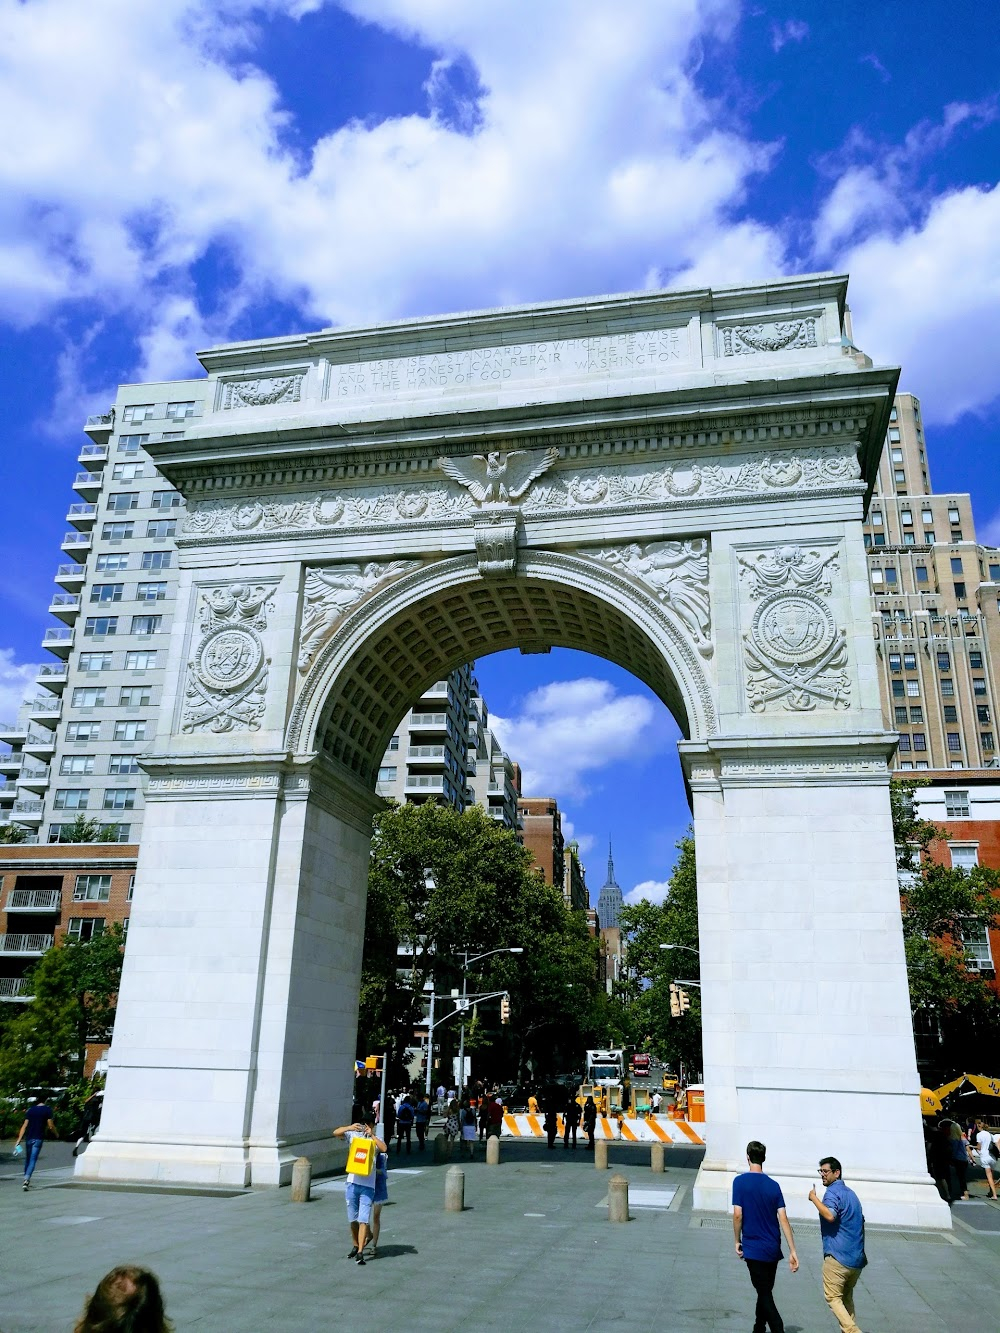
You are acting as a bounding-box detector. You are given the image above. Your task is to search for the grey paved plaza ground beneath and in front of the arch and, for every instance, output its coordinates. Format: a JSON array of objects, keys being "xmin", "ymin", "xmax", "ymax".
[{"xmin": 0, "ymin": 1141, "xmax": 1000, "ymax": 1333}]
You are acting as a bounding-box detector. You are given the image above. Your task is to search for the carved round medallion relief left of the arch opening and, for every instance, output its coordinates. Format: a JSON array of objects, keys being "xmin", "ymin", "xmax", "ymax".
[{"xmin": 181, "ymin": 584, "xmax": 273, "ymax": 732}]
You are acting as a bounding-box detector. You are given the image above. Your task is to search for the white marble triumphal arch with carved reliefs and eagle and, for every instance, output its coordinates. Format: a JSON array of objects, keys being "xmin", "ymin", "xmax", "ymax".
[{"xmin": 76, "ymin": 275, "xmax": 949, "ymax": 1226}]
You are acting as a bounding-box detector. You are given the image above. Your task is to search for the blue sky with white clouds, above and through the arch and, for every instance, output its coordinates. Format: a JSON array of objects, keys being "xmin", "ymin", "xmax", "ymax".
[{"xmin": 0, "ymin": 0, "xmax": 1000, "ymax": 892}]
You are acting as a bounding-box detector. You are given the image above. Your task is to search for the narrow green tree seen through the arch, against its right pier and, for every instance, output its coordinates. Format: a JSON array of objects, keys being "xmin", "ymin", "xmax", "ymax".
[{"xmin": 621, "ymin": 833, "xmax": 701, "ymax": 1069}]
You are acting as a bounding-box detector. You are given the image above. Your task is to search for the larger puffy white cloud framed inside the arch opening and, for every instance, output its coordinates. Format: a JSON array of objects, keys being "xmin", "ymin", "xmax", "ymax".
[{"xmin": 492, "ymin": 676, "xmax": 656, "ymax": 801}]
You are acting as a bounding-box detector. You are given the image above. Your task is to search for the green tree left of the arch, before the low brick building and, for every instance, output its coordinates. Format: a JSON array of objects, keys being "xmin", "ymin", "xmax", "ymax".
[{"xmin": 0, "ymin": 922, "xmax": 124, "ymax": 1094}]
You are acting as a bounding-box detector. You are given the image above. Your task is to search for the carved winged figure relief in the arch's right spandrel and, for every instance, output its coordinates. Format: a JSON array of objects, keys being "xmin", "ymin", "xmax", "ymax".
[{"xmin": 580, "ymin": 537, "xmax": 715, "ymax": 657}]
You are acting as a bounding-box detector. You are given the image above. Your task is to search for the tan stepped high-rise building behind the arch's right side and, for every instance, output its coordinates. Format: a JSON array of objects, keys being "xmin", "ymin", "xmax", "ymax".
[{"xmin": 864, "ymin": 393, "xmax": 1000, "ymax": 770}]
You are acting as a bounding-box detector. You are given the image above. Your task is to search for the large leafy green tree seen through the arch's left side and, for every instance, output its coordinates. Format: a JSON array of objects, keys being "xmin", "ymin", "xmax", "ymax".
[{"xmin": 359, "ymin": 802, "xmax": 597, "ymax": 1070}]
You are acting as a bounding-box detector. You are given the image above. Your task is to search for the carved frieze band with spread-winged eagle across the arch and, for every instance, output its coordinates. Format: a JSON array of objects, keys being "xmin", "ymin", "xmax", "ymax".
[{"xmin": 181, "ymin": 441, "xmax": 861, "ymax": 540}]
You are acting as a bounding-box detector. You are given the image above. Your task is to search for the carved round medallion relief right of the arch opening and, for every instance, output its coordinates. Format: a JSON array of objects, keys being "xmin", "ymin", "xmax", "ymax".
[{"xmin": 736, "ymin": 545, "xmax": 851, "ymax": 713}]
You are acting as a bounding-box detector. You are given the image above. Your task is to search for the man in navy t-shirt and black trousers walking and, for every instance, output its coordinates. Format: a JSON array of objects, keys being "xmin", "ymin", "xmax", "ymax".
[{"xmin": 732, "ymin": 1140, "xmax": 799, "ymax": 1333}]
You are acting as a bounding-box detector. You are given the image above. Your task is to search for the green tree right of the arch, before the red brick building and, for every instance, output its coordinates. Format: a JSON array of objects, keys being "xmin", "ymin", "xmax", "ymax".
[{"xmin": 889, "ymin": 781, "xmax": 1000, "ymax": 1037}]
